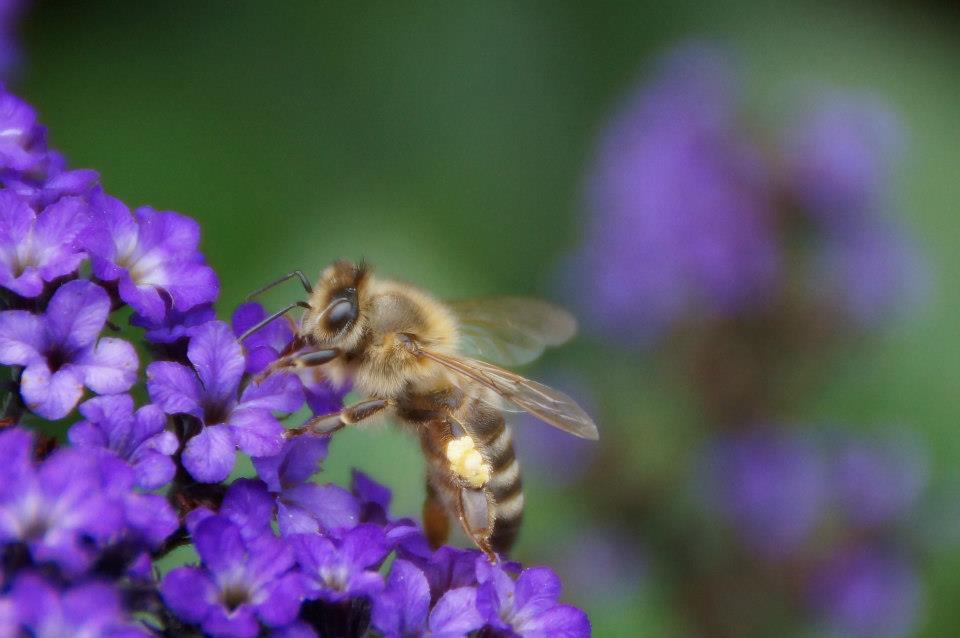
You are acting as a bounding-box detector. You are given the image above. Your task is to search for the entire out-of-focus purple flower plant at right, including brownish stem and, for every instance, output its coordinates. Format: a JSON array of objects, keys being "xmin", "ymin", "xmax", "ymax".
[{"xmin": 560, "ymin": 43, "xmax": 935, "ymax": 638}]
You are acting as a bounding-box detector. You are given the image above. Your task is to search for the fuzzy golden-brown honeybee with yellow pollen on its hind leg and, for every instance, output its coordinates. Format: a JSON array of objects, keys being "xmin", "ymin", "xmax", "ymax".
[{"xmin": 241, "ymin": 261, "xmax": 598, "ymax": 560}]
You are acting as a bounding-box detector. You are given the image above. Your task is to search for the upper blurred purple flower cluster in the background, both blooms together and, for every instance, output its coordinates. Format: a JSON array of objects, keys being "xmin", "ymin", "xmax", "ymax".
[{"xmin": 568, "ymin": 45, "xmax": 921, "ymax": 340}]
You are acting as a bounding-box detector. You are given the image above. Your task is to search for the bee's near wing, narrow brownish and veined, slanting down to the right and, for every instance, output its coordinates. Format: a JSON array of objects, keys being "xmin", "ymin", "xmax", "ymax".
[{"xmin": 418, "ymin": 349, "xmax": 600, "ymax": 440}]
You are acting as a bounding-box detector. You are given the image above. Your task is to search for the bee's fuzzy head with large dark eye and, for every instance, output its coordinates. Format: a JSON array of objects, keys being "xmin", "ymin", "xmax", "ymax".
[{"xmin": 301, "ymin": 261, "xmax": 370, "ymax": 350}]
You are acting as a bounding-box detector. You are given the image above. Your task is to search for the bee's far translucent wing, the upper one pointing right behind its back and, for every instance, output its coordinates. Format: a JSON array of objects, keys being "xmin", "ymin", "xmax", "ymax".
[{"xmin": 447, "ymin": 297, "xmax": 577, "ymax": 366}]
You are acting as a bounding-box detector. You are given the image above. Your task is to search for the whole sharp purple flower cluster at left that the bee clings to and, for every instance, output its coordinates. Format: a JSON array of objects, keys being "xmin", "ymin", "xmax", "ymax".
[{"xmin": 0, "ymin": 86, "xmax": 590, "ymax": 638}]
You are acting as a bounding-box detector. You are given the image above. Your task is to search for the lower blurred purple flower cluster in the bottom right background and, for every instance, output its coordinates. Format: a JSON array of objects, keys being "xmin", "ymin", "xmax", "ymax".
[{"xmin": 697, "ymin": 428, "xmax": 926, "ymax": 638}]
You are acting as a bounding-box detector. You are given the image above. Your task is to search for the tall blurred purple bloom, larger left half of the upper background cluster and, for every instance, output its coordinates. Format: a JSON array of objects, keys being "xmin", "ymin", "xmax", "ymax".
[{"xmin": 571, "ymin": 46, "xmax": 778, "ymax": 338}]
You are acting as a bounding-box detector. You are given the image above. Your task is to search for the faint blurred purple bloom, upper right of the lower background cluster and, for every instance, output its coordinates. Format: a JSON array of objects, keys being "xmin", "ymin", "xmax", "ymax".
[{"xmin": 831, "ymin": 432, "xmax": 927, "ymax": 527}]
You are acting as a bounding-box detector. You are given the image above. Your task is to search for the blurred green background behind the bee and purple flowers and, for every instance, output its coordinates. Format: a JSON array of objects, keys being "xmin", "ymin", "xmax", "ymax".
[{"xmin": 13, "ymin": 0, "xmax": 960, "ymax": 636}]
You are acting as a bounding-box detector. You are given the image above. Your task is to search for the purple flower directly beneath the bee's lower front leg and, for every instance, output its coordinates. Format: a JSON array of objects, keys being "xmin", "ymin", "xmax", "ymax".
[{"xmin": 253, "ymin": 436, "xmax": 360, "ymax": 536}]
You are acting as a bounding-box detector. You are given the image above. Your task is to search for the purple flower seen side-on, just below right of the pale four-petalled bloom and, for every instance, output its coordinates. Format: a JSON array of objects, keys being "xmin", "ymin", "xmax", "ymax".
[{"xmin": 67, "ymin": 394, "xmax": 177, "ymax": 490}]
